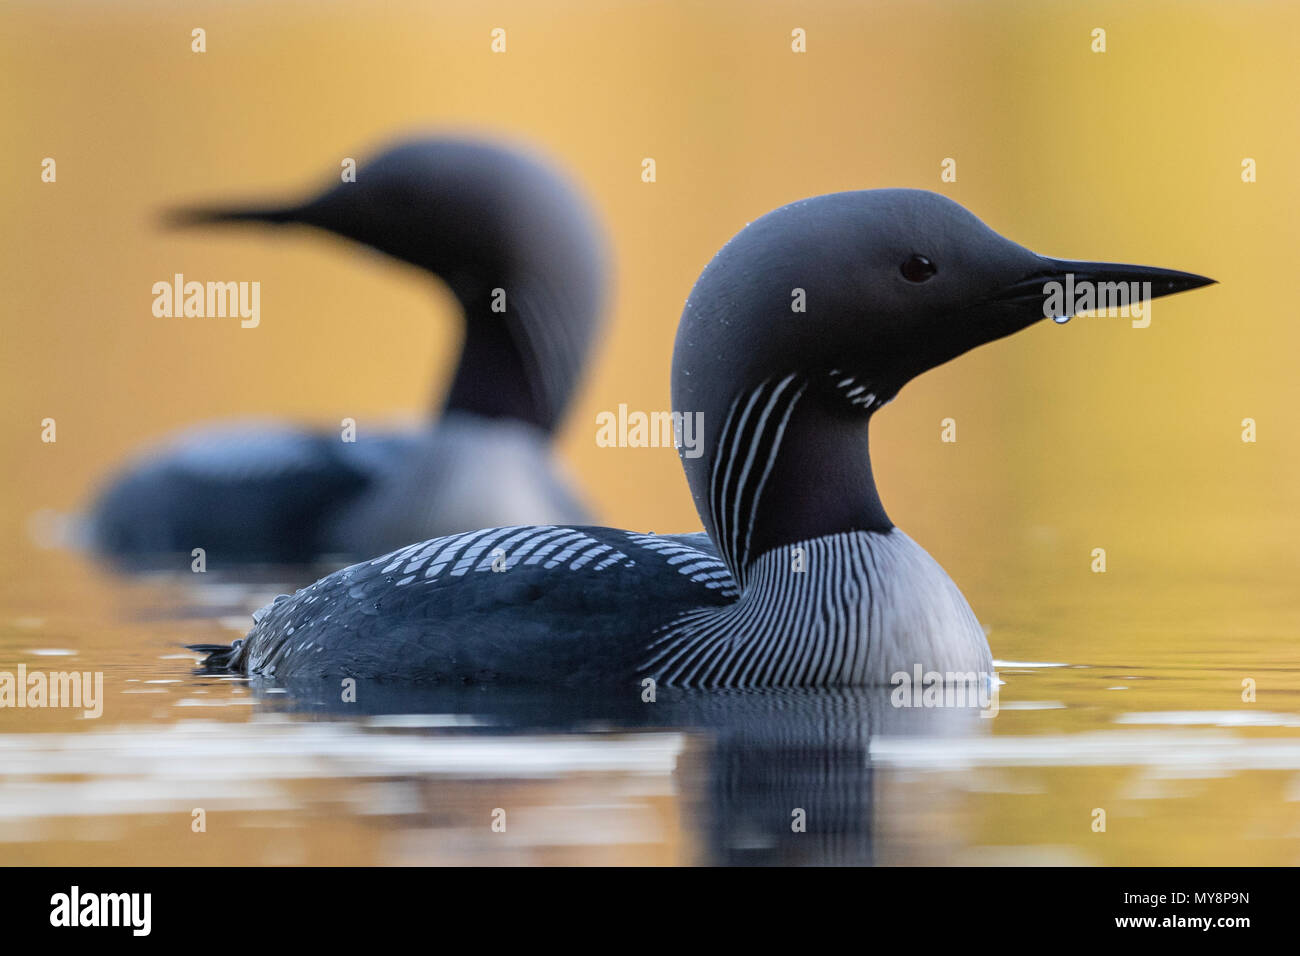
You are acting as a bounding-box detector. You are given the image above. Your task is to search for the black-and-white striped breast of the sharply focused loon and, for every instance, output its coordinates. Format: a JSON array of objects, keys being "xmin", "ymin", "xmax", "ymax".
[{"xmin": 640, "ymin": 528, "xmax": 992, "ymax": 687}]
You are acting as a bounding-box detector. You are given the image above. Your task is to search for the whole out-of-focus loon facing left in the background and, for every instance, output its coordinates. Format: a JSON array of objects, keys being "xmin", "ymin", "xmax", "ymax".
[{"xmin": 87, "ymin": 138, "xmax": 606, "ymax": 566}]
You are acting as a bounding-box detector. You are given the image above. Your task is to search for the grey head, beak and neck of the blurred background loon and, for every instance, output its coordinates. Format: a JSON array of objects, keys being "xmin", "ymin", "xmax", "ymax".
[{"xmin": 172, "ymin": 137, "xmax": 607, "ymax": 431}]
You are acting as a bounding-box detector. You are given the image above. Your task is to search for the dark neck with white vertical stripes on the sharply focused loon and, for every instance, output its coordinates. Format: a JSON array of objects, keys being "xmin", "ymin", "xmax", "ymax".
[{"xmin": 705, "ymin": 373, "xmax": 893, "ymax": 588}]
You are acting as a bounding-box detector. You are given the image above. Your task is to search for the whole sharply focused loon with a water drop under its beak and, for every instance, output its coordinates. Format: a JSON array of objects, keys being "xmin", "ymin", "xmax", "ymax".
[{"xmin": 195, "ymin": 189, "xmax": 1213, "ymax": 688}]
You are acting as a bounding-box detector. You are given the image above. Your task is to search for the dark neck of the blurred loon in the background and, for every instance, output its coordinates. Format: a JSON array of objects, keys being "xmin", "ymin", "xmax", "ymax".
[{"xmin": 443, "ymin": 282, "xmax": 588, "ymax": 432}]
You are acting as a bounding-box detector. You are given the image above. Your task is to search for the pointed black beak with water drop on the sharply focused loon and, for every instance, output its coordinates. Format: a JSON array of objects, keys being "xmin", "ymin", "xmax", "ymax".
[{"xmin": 997, "ymin": 258, "xmax": 1216, "ymax": 319}]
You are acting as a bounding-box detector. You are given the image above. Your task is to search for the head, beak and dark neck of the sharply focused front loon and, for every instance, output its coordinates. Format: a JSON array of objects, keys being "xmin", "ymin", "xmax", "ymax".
[{"xmin": 672, "ymin": 189, "xmax": 1213, "ymax": 575}]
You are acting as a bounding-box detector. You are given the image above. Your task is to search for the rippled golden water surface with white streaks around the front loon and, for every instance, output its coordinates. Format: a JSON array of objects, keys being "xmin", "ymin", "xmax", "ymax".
[{"xmin": 0, "ymin": 538, "xmax": 1300, "ymax": 865}]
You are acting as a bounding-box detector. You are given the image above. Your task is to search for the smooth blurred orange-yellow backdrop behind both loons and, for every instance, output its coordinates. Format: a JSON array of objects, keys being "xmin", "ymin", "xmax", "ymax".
[{"xmin": 0, "ymin": 3, "xmax": 1300, "ymax": 653}]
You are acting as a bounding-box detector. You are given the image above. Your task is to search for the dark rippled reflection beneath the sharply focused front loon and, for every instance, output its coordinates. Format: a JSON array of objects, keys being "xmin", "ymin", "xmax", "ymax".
[{"xmin": 236, "ymin": 679, "xmax": 992, "ymax": 865}]
